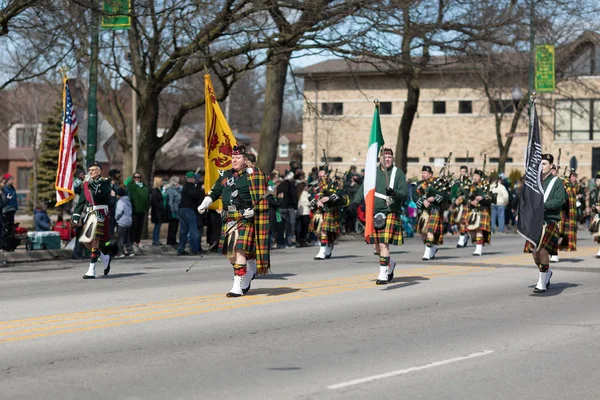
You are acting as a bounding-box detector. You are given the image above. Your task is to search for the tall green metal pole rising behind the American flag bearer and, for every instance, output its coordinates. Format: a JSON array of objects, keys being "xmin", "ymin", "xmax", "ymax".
[{"xmin": 86, "ymin": 1, "xmax": 99, "ymax": 167}]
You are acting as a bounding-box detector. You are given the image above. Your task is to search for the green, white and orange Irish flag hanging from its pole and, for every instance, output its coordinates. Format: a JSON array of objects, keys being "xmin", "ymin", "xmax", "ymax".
[{"xmin": 363, "ymin": 104, "xmax": 384, "ymax": 242}]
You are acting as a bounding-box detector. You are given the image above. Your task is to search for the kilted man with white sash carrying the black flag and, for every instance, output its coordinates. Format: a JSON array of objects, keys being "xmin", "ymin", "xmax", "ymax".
[{"xmin": 525, "ymin": 154, "xmax": 567, "ymax": 293}]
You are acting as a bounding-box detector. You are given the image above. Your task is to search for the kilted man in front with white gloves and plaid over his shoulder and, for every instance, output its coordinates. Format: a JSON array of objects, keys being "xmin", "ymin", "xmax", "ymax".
[{"xmin": 198, "ymin": 146, "xmax": 270, "ymax": 297}]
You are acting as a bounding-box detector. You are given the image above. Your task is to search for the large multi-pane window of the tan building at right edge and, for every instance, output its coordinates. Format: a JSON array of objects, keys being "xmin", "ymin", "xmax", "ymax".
[{"xmin": 554, "ymin": 99, "xmax": 600, "ymax": 140}]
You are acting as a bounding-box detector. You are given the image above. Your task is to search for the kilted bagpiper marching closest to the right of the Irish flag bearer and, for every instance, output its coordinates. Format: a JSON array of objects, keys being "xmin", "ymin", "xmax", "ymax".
[{"xmin": 416, "ymin": 165, "xmax": 448, "ymax": 260}]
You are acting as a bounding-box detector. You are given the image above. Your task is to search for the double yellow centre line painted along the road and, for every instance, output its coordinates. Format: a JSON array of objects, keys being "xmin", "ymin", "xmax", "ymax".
[{"xmin": 0, "ymin": 265, "xmax": 494, "ymax": 342}]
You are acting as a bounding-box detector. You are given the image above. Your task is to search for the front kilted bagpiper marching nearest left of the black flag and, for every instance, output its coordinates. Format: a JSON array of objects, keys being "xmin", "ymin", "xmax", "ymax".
[{"xmin": 467, "ymin": 170, "xmax": 492, "ymax": 256}]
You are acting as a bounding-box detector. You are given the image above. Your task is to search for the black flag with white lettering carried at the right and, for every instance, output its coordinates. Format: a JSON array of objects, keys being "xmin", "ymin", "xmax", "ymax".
[{"xmin": 517, "ymin": 100, "xmax": 544, "ymax": 249}]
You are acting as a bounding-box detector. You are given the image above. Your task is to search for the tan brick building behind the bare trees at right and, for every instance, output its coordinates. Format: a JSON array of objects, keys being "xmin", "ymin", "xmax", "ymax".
[{"xmin": 295, "ymin": 33, "xmax": 600, "ymax": 178}]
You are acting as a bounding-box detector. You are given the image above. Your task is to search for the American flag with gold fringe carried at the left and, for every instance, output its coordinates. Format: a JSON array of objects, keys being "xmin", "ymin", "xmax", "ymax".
[{"xmin": 54, "ymin": 78, "xmax": 77, "ymax": 207}]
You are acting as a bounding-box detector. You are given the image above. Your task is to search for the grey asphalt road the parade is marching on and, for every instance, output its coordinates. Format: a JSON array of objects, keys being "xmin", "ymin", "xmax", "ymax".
[{"xmin": 0, "ymin": 231, "xmax": 600, "ymax": 399}]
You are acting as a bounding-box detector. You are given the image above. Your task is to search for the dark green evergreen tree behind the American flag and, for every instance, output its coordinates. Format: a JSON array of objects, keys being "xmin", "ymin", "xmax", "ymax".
[{"xmin": 30, "ymin": 102, "xmax": 81, "ymax": 207}]
